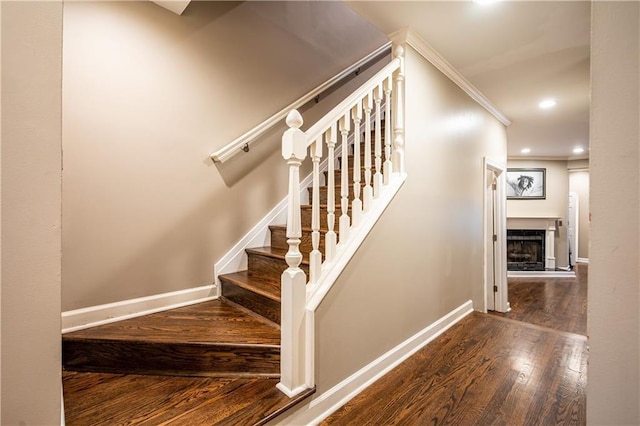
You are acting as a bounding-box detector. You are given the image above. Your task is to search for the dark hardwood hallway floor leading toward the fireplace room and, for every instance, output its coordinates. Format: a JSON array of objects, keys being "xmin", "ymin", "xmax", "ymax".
[{"xmin": 322, "ymin": 265, "xmax": 588, "ymax": 425}]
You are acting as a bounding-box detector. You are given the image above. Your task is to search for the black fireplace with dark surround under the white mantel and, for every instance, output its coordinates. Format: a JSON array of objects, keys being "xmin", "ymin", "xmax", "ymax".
[{"xmin": 507, "ymin": 229, "xmax": 545, "ymax": 271}]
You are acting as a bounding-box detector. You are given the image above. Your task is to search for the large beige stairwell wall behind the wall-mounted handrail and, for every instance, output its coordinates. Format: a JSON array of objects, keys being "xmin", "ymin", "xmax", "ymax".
[{"xmin": 62, "ymin": 2, "xmax": 386, "ymax": 311}]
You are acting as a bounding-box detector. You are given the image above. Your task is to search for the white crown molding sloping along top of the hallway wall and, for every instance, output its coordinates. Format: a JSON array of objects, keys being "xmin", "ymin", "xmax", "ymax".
[{"xmin": 389, "ymin": 28, "xmax": 511, "ymax": 126}]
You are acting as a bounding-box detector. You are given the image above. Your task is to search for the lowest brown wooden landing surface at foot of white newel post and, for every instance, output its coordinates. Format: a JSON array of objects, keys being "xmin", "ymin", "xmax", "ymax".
[{"xmin": 62, "ymin": 372, "xmax": 315, "ymax": 426}]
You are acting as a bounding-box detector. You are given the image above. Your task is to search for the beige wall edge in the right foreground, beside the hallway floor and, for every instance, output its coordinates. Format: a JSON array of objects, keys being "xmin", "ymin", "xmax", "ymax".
[{"xmin": 587, "ymin": 1, "xmax": 640, "ymax": 425}]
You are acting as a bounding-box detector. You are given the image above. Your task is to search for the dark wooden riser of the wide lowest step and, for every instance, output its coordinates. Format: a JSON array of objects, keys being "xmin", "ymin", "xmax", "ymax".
[{"xmin": 62, "ymin": 339, "xmax": 280, "ymax": 376}]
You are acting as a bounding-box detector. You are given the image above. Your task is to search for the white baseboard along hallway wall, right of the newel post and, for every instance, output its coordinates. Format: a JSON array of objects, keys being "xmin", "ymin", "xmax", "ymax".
[{"xmin": 275, "ymin": 300, "xmax": 473, "ymax": 425}]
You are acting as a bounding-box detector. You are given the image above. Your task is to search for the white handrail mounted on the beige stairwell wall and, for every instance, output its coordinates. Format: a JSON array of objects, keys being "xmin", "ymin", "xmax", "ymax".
[{"xmin": 211, "ymin": 42, "xmax": 391, "ymax": 163}]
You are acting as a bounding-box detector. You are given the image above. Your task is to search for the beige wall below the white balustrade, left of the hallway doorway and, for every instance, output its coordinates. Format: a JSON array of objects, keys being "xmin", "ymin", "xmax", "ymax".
[{"xmin": 284, "ymin": 43, "xmax": 506, "ymax": 416}]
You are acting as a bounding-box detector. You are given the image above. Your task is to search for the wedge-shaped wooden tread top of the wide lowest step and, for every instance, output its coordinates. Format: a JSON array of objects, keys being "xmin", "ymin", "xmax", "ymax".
[{"xmin": 63, "ymin": 299, "xmax": 280, "ymax": 346}]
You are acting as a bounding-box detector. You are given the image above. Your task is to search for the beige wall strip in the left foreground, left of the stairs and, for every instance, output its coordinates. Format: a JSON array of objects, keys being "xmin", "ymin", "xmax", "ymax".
[{"xmin": 0, "ymin": 1, "xmax": 62, "ymax": 426}]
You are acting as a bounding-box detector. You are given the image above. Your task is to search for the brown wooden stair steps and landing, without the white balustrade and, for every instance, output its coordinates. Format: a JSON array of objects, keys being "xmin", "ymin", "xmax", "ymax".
[{"xmin": 63, "ymin": 135, "xmax": 382, "ymax": 425}]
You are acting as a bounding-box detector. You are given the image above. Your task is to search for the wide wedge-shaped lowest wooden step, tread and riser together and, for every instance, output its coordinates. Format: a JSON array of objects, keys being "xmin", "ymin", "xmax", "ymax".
[{"xmin": 62, "ymin": 299, "xmax": 280, "ymax": 377}]
